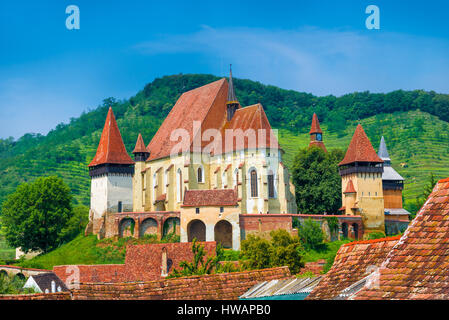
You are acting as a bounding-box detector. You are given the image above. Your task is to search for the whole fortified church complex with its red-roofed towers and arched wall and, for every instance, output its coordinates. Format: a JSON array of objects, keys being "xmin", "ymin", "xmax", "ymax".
[{"xmin": 86, "ymin": 71, "xmax": 408, "ymax": 250}]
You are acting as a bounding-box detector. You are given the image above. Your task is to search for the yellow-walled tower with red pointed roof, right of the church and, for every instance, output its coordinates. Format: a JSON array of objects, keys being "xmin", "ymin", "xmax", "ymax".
[{"xmin": 339, "ymin": 124, "xmax": 385, "ymax": 234}]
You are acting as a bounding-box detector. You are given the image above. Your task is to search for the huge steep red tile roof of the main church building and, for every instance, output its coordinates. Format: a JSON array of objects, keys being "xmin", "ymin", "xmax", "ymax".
[{"xmin": 147, "ymin": 78, "xmax": 279, "ymax": 161}]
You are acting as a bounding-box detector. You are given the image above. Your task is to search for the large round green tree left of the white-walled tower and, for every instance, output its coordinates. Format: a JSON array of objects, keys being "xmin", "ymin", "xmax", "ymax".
[{"xmin": 1, "ymin": 176, "xmax": 72, "ymax": 252}]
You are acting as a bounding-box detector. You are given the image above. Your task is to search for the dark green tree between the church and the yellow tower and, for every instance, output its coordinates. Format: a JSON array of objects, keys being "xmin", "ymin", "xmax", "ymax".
[{"xmin": 292, "ymin": 146, "xmax": 344, "ymax": 214}]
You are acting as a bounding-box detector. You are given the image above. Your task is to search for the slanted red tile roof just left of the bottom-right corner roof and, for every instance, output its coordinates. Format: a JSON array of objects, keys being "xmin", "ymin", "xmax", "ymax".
[{"xmin": 307, "ymin": 237, "xmax": 400, "ymax": 299}]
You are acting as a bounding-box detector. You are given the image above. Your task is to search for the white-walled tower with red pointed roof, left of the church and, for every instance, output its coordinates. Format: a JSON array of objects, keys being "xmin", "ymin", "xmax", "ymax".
[{"xmin": 88, "ymin": 108, "xmax": 134, "ymax": 234}]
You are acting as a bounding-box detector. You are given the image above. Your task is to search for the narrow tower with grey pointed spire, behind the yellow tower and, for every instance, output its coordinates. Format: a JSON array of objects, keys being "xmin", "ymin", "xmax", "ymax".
[{"xmin": 377, "ymin": 136, "xmax": 410, "ymax": 219}]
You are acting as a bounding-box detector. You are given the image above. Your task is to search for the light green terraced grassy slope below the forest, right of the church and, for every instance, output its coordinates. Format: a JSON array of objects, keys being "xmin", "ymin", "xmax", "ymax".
[{"xmin": 279, "ymin": 111, "xmax": 449, "ymax": 210}]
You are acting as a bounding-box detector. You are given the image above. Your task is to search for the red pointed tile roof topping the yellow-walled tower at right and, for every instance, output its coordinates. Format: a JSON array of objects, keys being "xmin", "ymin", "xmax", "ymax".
[{"xmin": 339, "ymin": 124, "xmax": 383, "ymax": 166}]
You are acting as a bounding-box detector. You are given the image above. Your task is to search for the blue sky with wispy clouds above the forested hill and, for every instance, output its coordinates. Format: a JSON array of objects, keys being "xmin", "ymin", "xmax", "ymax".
[{"xmin": 0, "ymin": 0, "xmax": 449, "ymax": 138}]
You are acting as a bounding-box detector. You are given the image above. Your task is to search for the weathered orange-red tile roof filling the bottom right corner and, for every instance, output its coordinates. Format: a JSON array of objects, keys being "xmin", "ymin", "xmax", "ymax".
[{"xmin": 355, "ymin": 179, "xmax": 449, "ymax": 300}]
